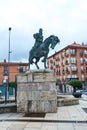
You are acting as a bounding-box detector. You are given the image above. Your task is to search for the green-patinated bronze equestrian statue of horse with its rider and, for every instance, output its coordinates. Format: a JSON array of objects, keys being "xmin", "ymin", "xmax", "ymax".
[{"xmin": 28, "ymin": 28, "xmax": 60, "ymax": 70}]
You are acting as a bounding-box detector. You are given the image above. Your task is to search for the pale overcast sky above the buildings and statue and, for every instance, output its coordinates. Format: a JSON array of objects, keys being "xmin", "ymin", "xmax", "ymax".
[{"xmin": 0, "ymin": 0, "xmax": 87, "ymax": 67}]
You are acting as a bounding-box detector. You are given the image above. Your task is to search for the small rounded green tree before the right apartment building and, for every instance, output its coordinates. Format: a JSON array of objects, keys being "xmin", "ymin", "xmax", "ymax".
[{"xmin": 68, "ymin": 80, "xmax": 82, "ymax": 92}]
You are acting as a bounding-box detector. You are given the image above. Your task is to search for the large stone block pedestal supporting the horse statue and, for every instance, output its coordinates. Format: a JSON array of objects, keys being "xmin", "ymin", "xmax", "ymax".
[{"xmin": 17, "ymin": 70, "xmax": 57, "ymax": 113}]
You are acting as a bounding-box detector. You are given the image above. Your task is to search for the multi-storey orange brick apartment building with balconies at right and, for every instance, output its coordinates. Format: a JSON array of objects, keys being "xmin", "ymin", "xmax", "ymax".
[{"xmin": 47, "ymin": 42, "xmax": 87, "ymax": 82}]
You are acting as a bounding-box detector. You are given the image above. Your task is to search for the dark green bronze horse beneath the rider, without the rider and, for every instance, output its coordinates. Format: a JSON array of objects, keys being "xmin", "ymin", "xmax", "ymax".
[{"xmin": 28, "ymin": 35, "xmax": 60, "ymax": 70}]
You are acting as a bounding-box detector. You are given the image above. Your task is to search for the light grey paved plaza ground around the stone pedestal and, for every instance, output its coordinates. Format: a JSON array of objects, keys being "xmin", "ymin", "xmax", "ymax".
[{"xmin": 0, "ymin": 95, "xmax": 87, "ymax": 130}]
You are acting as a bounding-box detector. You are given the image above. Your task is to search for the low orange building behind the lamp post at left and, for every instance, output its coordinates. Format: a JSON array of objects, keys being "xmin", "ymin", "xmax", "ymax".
[{"xmin": 0, "ymin": 60, "xmax": 28, "ymax": 85}]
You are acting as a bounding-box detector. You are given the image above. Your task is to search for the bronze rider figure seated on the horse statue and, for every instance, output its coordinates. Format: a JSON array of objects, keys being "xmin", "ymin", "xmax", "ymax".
[{"xmin": 33, "ymin": 28, "xmax": 43, "ymax": 49}]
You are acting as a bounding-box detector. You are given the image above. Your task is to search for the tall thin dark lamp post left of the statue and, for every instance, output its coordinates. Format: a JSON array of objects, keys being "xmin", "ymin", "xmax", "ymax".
[{"xmin": 6, "ymin": 27, "xmax": 11, "ymax": 100}]
